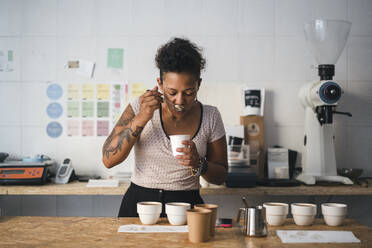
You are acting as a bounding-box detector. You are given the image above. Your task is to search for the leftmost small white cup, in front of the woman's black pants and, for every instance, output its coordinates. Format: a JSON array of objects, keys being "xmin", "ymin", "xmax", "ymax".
[{"xmin": 137, "ymin": 202, "xmax": 162, "ymax": 225}]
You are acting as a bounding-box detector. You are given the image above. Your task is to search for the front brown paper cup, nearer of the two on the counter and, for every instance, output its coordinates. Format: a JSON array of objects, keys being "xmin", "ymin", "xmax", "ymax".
[{"xmin": 186, "ymin": 208, "xmax": 212, "ymax": 243}]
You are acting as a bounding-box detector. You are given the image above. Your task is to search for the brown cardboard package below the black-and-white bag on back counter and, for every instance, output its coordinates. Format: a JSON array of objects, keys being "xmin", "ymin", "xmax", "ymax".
[{"xmin": 240, "ymin": 116, "xmax": 265, "ymax": 178}]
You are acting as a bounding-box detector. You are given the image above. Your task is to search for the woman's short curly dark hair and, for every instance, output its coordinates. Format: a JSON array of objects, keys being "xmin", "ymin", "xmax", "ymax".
[{"xmin": 155, "ymin": 38, "xmax": 205, "ymax": 81}]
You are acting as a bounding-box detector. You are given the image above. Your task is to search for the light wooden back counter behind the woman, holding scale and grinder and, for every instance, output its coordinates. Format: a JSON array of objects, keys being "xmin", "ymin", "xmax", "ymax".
[{"xmin": 0, "ymin": 181, "xmax": 372, "ymax": 196}]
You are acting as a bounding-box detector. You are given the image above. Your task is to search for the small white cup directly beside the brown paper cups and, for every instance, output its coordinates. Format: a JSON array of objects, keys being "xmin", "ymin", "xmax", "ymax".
[{"xmin": 165, "ymin": 202, "xmax": 191, "ymax": 226}]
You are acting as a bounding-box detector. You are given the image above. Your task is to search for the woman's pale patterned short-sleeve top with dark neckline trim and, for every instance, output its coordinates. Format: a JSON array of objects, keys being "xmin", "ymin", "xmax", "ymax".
[{"xmin": 130, "ymin": 97, "xmax": 225, "ymax": 190}]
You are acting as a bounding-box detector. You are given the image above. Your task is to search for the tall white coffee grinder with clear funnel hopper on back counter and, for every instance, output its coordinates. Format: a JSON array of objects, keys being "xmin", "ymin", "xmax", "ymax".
[{"xmin": 296, "ymin": 20, "xmax": 353, "ymax": 184}]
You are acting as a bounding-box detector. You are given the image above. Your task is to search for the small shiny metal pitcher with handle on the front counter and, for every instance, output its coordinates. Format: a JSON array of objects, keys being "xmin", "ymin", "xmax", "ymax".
[{"xmin": 236, "ymin": 206, "xmax": 267, "ymax": 237}]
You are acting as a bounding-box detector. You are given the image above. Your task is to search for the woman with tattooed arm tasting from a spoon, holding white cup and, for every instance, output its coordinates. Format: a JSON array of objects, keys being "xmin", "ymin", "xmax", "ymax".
[{"xmin": 103, "ymin": 38, "xmax": 227, "ymax": 217}]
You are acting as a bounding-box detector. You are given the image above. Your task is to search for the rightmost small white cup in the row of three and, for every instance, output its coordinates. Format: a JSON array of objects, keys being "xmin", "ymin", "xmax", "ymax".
[{"xmin": 322, "ymin": 203, "xmax": 347, "ymax": 226}]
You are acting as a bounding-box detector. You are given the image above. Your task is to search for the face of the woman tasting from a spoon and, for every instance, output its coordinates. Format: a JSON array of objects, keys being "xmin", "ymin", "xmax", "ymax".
[{"xmin": 157, "ymin": 72, "xmax": 201, "ymax": 116}]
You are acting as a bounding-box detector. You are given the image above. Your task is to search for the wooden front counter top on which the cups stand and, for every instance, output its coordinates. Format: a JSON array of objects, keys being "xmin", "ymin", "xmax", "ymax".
[{"xmin": 0, "ymin": 217, "xmax": 372, "ymax": 248}]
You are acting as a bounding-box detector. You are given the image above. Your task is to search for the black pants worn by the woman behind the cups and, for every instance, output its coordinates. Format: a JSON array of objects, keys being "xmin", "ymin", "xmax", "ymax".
[{"xmin": 118, "ymin": 183, "xmax": 204, "ymax": 217}]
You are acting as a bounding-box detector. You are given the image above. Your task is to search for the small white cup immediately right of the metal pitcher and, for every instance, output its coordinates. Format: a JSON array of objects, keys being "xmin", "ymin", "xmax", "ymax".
[{"xmin": 263, "ymin": 202, "xmax": 289, "ymax": 226}]
